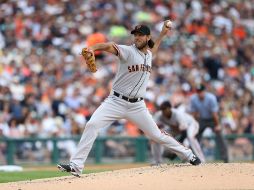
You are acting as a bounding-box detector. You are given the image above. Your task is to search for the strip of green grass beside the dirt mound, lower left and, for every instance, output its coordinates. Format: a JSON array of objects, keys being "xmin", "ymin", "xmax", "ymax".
[{"xmin": 0, "ymin": 170, "xmax": 106, "ymax": 183}]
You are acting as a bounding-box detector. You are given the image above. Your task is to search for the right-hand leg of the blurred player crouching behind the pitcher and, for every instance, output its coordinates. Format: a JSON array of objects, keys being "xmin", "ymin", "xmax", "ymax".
[{"xmin": 187, "ymin": 122, "xmax": 205, "ymax": 163}]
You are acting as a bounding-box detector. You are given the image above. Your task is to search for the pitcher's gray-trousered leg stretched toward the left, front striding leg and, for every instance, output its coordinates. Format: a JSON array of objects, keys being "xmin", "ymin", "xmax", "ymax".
[{"xmin": 59, "ymin": 96, "xmax": 126, "ymax": 173}]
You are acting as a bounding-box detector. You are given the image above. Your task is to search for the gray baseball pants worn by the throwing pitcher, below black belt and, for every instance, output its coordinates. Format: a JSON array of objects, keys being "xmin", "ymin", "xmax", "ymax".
[{"xmin": 70, "ymin": 95, "xmax": 194, "ymax": 173}]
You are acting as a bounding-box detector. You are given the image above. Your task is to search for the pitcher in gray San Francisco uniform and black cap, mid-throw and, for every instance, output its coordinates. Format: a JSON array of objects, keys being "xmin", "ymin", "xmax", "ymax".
[{"xmin": 57, "ymin": 21, "xmax": 201, "ymax": 177}]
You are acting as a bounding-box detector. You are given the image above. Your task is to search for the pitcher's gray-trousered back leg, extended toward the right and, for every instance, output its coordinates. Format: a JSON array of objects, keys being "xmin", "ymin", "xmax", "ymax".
[{"xmin": 126, "ymin": 101, "xmax": 194, "ymax": 161}]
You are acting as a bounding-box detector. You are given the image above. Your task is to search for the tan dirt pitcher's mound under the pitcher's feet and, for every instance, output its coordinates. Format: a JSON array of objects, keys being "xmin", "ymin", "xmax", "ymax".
[{"xmin": 0, "ymin": 163, "xmax": 254, "ymax": 190}]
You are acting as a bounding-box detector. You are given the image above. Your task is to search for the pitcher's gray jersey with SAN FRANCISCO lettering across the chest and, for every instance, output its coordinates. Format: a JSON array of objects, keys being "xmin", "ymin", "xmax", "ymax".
[{"xmin": 112, "ymin": 44, "xmax": 152, "ymax": 98}]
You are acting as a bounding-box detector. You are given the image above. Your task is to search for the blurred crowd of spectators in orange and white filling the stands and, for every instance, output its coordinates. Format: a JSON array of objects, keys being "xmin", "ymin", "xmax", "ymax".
[{"xmin": 0, "ymin": 0, "xmax": 254, "ymax": 149}]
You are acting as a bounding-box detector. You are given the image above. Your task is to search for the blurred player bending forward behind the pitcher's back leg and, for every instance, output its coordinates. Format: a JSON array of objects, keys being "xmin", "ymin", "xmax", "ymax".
[{"xmin": 151, "ymin": 101, "xmax": 205, "ymax": 164}]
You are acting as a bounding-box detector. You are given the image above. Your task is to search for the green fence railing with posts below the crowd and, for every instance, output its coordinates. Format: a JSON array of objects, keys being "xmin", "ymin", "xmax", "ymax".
[{"xmin": 0, "ymin": 134, "xmax": 254, "ymax": 165}]
